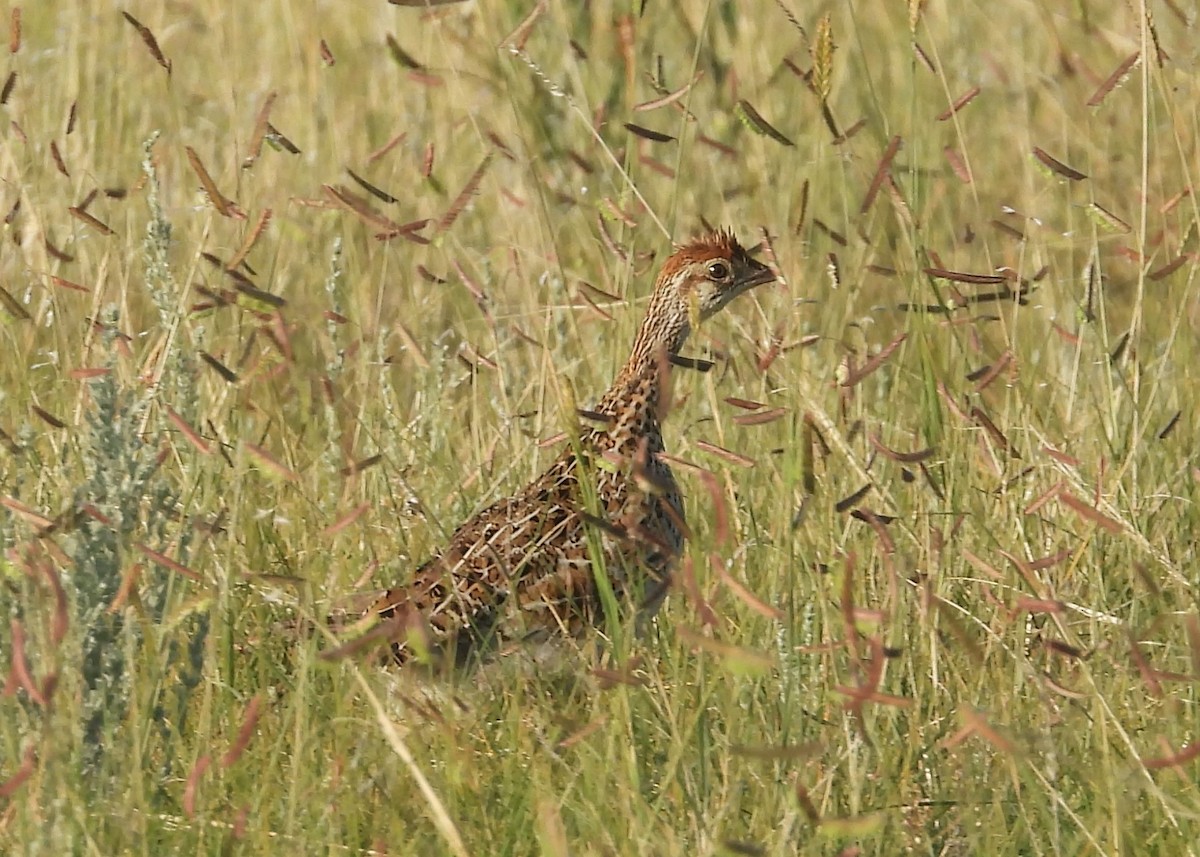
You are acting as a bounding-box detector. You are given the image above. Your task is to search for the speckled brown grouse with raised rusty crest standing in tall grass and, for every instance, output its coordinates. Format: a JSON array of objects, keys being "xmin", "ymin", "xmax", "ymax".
[{"xmin": 372, "ymin": 226, "xmax": 774, "ymax": 663}]
